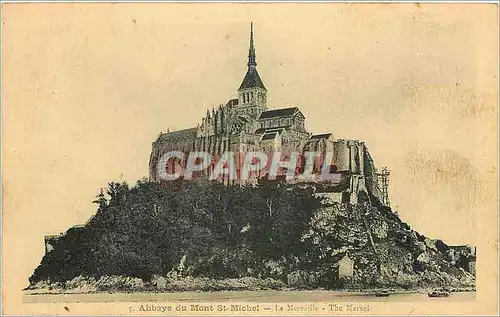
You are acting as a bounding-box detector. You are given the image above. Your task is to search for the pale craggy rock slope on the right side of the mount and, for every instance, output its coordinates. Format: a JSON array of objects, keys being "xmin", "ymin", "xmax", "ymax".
[{"xmin": 303, "ymin": 203, "xmax": 475, "ymax": 288}]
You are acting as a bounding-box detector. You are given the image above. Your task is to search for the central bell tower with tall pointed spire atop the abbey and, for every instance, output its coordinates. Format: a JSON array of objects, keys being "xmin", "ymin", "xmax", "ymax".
[{"xmin": 238, "ymin": 23, "xmax": 267, "ymax": 118}]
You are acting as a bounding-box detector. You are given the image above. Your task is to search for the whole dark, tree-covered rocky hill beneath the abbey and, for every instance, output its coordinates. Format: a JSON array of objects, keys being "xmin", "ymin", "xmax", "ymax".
[{"xmin": 30, "ymin": 182, "xmax": 476, "ymax": 291}]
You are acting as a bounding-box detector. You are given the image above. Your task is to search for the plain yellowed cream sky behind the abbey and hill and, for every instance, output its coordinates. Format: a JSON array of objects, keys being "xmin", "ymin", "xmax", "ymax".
[{"xmin": 2, "ymin": 3, "xmax": 498, "ymax": 298}]
